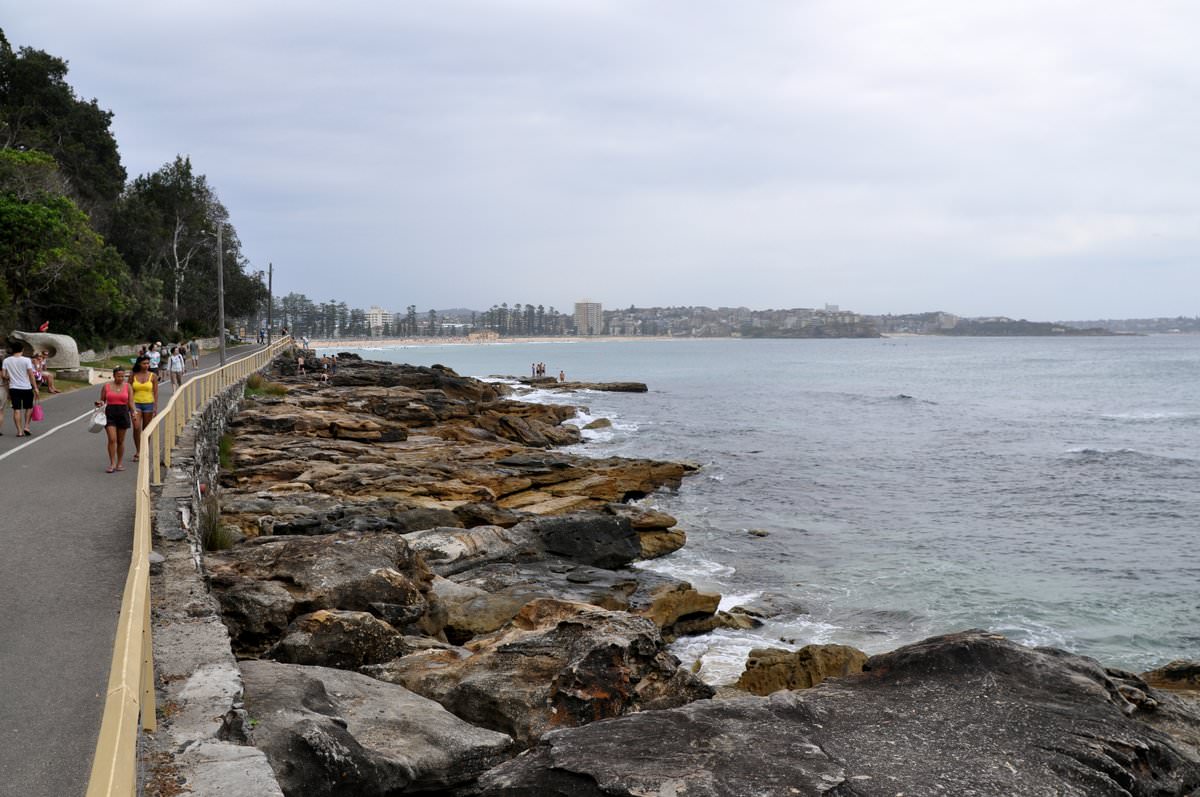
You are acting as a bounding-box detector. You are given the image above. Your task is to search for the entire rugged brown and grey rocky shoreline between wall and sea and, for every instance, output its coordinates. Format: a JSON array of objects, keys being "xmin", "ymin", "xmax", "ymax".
[{"xmin": 184, "ymin": 355, "xmax": 1200, "ymax": 797}]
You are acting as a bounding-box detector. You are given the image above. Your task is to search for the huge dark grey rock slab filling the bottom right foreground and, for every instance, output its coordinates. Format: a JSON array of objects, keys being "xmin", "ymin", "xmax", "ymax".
[{"xmin": 478, "ymin": 631, "xmax": 1200, "ymax": 797}]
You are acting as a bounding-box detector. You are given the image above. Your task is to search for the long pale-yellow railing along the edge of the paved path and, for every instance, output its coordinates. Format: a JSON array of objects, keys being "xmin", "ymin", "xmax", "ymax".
[{"xmin": 88, "ymin": 337, "xmax": 292, "ymax": 797}]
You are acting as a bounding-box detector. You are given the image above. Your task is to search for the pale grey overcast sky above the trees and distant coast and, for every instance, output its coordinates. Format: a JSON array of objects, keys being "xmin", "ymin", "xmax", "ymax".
[{"xmin": 9, "ymin": 0, "xmax": 1200, "ymax": 319}]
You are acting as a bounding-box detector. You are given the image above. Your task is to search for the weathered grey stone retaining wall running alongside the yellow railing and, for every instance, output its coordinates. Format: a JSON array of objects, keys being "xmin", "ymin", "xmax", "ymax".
[{"xmin": 142, "ymin": 369, "xmax": 282, "ymax": 797}]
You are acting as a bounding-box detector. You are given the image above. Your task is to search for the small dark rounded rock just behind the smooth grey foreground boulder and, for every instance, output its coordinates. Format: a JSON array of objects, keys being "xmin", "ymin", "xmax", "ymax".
[{"xmin": 266, "ymin": 609, "xmax": 407, "ymax": 670}]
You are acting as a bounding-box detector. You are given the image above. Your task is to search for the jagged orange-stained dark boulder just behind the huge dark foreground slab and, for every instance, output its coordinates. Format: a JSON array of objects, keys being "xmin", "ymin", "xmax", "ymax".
[{"xmin": 364, "ymin": 599, "xmax": 713, "ymax": 745}]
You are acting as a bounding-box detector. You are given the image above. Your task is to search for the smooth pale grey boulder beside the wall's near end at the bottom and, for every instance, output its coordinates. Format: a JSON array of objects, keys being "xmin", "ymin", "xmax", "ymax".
[{"xmin": 240, "ymin": 661, "xmax": 512, "ymax": 797}]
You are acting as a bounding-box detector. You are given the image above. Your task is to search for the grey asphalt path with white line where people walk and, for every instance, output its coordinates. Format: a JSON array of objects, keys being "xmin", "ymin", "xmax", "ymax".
[{"xmin": 0, "ymin": 348, "xmax": 260, "ymax": 797}]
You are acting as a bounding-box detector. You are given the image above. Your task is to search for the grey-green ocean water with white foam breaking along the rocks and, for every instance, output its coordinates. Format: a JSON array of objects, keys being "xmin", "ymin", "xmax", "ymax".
[{"xmin": 321, "ymin": 336, "xmax": 1200, "ymax": 683}]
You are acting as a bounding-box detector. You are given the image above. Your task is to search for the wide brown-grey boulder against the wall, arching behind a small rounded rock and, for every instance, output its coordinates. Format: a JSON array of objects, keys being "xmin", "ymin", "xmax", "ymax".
[{"xmin": 205, "ymin": 532, "xmax": 444, "ymax": 653}]
